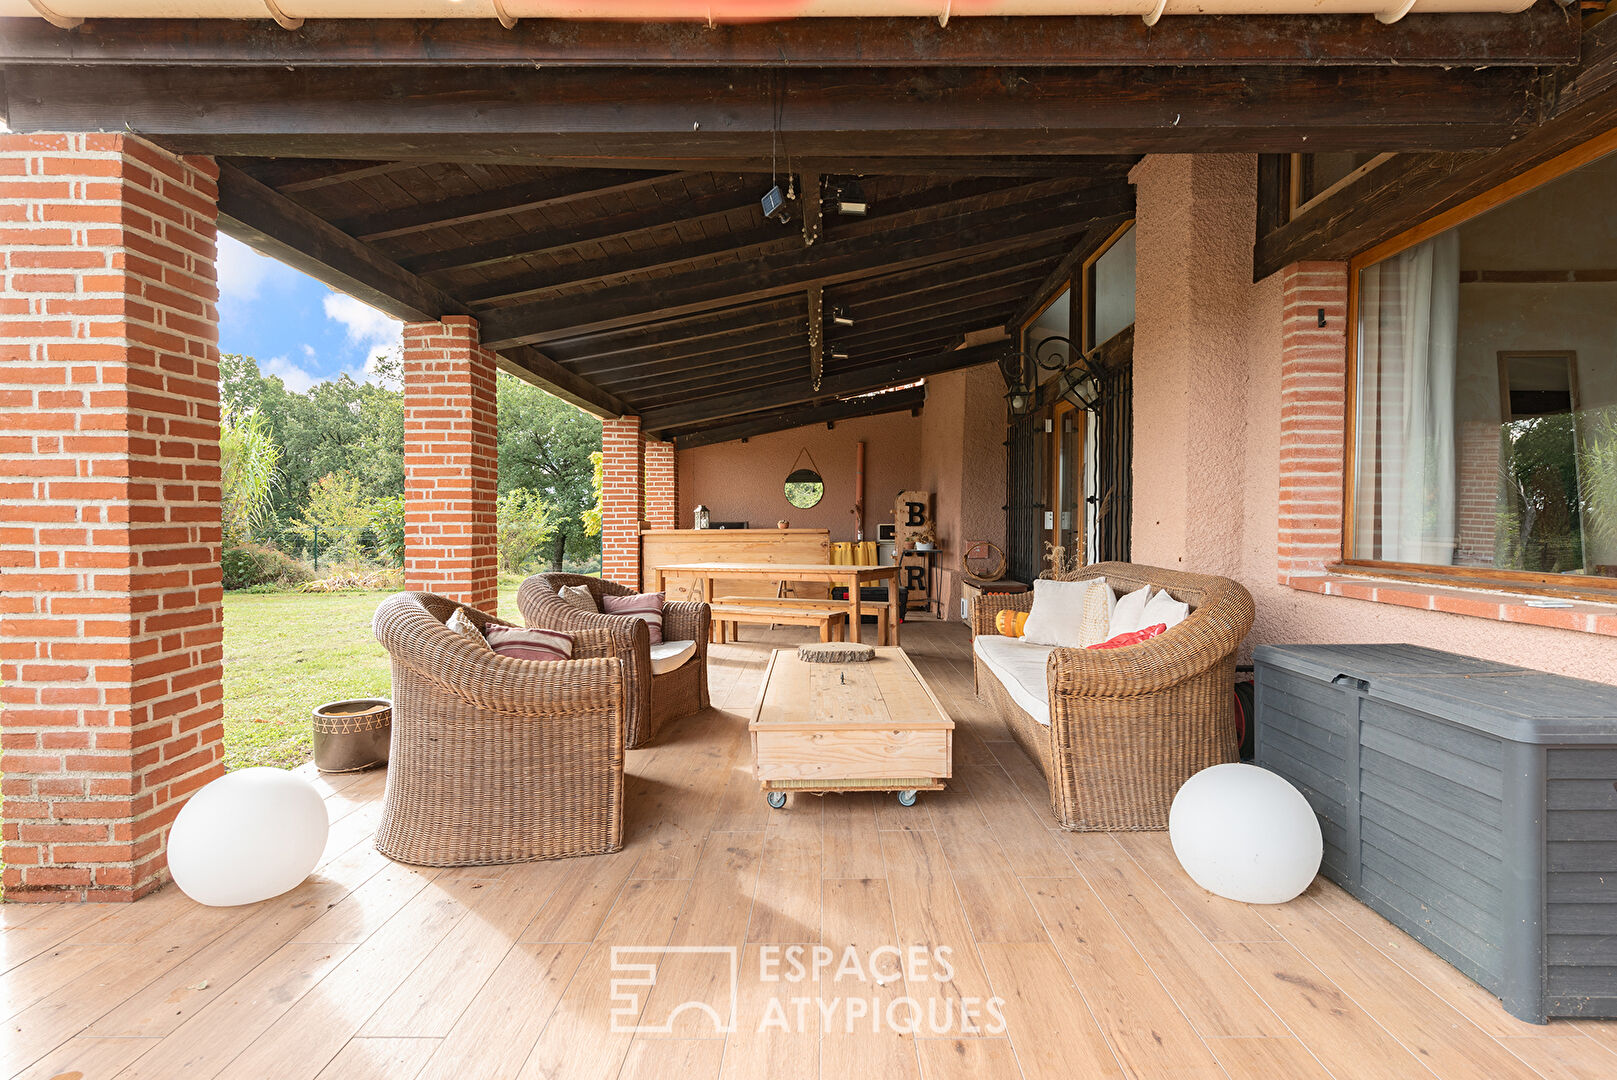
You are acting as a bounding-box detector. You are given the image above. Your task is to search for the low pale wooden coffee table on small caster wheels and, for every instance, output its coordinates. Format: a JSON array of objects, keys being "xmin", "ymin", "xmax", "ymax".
[{"xmin": 749, "ymin": 647, "xmax": 954, "ymax": 808}]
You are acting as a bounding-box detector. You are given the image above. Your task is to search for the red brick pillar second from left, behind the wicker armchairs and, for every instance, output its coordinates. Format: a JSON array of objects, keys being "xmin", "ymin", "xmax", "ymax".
[{"xmin": 404, "ymin": 315, "xmax": 500, "ymax": 613}]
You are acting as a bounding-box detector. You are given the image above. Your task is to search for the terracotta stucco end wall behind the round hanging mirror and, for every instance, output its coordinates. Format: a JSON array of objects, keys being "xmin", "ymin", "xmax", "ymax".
[{"xmin": 679, "ymin": 409, "xmax": 931, "ymax": 540}]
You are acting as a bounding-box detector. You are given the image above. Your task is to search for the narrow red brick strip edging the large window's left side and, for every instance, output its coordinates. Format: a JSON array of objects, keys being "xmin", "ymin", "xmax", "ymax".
[{"xmin": 1279, "ymin": 262, "xmax": 1347, "ymax": 584}]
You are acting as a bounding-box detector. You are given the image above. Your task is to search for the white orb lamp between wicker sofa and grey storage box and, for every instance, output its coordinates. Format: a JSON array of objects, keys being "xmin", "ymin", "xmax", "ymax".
[{"xmin": 1167, "ymin": 765, "xmax": 1324, "ymax": 904}]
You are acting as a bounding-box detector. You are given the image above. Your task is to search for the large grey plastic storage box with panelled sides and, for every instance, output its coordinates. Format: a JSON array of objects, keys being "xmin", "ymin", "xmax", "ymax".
[{"xmin": 1255, "ymin": 645, "xmax": 1617, "ymax": 1023}]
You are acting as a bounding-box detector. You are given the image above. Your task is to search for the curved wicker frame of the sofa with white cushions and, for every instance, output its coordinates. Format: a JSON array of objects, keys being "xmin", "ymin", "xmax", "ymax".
[{"xmin": 972, "ymin": 563, "xmax": 1253, "ymax": 831}]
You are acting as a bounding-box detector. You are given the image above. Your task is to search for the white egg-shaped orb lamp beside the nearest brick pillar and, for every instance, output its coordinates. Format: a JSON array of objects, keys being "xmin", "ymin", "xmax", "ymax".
[{"xmin": 168, "ymin": 768, "xmax": 330, "ymax": 907}]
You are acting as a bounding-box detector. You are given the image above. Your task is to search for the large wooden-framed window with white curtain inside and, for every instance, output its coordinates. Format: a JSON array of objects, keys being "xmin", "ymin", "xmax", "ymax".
[{"xmin": 1342, "ymin": 131, "xmax": 1617, "ymax": 600}]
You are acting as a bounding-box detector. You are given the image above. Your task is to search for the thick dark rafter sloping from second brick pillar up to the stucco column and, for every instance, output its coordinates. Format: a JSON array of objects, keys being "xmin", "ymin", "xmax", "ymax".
[{"xmin": 483, "ymin": 185, "xmax": 1132, "ymax": 348}]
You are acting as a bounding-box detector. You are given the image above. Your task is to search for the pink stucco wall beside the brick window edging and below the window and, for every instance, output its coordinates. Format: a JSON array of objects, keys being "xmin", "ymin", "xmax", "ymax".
[{"xmin": 1132, "ymin": 155, "xmax": 1617, "ymax": 684}]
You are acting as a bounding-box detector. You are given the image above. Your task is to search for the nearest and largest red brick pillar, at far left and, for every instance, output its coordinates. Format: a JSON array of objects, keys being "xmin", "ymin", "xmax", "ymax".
[{"xmin": 0, "ymin": 134, "xmax": 225, "ymax": 901}]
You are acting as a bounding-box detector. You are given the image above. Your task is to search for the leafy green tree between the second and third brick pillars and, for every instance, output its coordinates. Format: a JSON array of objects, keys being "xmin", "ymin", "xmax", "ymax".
[{"xmin": 496, "ymin": 372, "xmax": 602, "ymax": 571}]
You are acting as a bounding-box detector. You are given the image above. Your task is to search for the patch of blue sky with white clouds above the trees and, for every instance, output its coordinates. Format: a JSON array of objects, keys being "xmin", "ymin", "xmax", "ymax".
[{"xmin": 218, "ymin": 234, "xmax": 401, "ymax": 393}]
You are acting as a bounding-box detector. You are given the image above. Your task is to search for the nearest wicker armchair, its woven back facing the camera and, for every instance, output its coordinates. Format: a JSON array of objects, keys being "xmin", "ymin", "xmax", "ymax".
[{"xmin": 374, "ymin": 592, "xmax": 624, "ymax": 867}]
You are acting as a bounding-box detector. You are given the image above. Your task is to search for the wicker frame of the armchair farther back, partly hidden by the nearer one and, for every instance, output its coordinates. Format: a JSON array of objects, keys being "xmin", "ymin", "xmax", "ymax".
[{"xmin": 516, "ymin": 574, "xmax": 713, "ymax": 749}]
